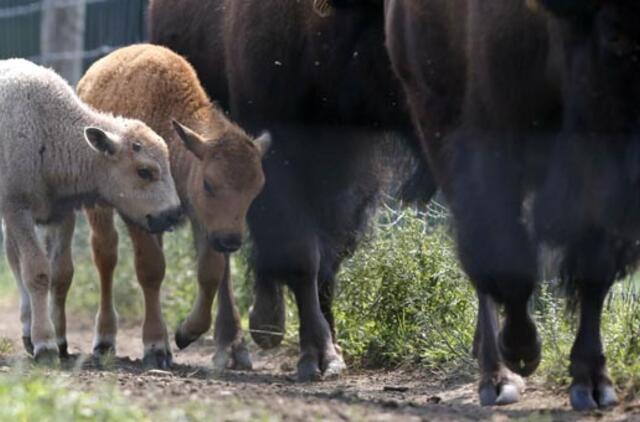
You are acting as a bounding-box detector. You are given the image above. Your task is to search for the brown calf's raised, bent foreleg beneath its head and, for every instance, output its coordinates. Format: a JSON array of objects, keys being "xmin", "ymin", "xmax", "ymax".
[{"xmin": 175, "ymin": 225, "xmax": 226, "ymax": 349}]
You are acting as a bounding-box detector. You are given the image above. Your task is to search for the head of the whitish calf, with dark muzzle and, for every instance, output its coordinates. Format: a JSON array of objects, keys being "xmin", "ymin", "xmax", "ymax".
[{"xmin": 85, "ymin": 120, "xmax": 180, "ymax": 233}]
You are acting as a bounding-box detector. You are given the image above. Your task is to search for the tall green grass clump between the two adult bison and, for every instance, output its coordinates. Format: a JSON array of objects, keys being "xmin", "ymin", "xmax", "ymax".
[{"xmin": 335, "ymin": 205, "xmax": 476, "ymax": 369}]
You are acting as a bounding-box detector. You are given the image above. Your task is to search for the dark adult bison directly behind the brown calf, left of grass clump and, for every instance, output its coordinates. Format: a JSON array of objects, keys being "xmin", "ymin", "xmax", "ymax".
[{"xmin": 149, "ymin": 0, "xmax": 435, "ymax": 380}]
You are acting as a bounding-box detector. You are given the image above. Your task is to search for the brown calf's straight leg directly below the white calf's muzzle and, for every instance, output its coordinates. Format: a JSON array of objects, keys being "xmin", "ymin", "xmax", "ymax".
[{"xmin": 127, "ymin": 225, "xmax": 172, "ymax": 369}]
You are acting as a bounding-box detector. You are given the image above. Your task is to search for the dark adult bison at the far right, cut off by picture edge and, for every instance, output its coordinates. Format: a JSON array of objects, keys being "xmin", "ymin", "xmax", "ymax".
[{"xmin": 385, "ymin": 0, "xmax": 640, "ymax": 410}]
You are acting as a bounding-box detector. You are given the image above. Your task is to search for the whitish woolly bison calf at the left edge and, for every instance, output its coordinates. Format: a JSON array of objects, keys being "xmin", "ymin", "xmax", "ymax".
[{"xmin": 0, "ymin": 59, "xmax": 180, "ymax": 362}]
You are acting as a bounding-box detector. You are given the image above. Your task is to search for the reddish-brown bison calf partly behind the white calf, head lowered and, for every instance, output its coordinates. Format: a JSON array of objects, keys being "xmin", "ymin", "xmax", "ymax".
[{"xmin": 78, "ymin": 44, "xmax": 269, "ymax": 368}]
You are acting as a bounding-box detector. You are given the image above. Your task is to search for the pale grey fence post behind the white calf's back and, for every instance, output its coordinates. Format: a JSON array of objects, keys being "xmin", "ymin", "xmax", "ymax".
[{"xmin": 40, "ymin": 0, "xmax": 85, "ymax": 84}]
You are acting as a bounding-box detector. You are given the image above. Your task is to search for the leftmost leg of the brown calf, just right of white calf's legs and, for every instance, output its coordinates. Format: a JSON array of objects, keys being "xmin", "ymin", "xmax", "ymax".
[{"xmin": 86, "ymin": 208, "xmax": 118, "ymax": 358}]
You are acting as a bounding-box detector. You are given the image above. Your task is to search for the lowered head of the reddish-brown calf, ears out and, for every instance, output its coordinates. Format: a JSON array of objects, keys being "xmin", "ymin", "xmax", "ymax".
[{"xmin": 173, "ymin": 121, "xmax": 271, "ymax": 253}]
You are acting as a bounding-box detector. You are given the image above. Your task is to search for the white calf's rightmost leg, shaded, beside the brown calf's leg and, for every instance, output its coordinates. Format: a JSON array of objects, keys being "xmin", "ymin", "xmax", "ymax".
[{"xmin": 45, "ymin": 212, "xmax": 76, "ymax": 358}]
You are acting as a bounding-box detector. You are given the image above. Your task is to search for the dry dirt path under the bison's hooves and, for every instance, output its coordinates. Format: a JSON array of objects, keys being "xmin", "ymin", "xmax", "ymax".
[{"xmin": 0, "ymin": 304, "xmax": 640, "ymax": 421}]
